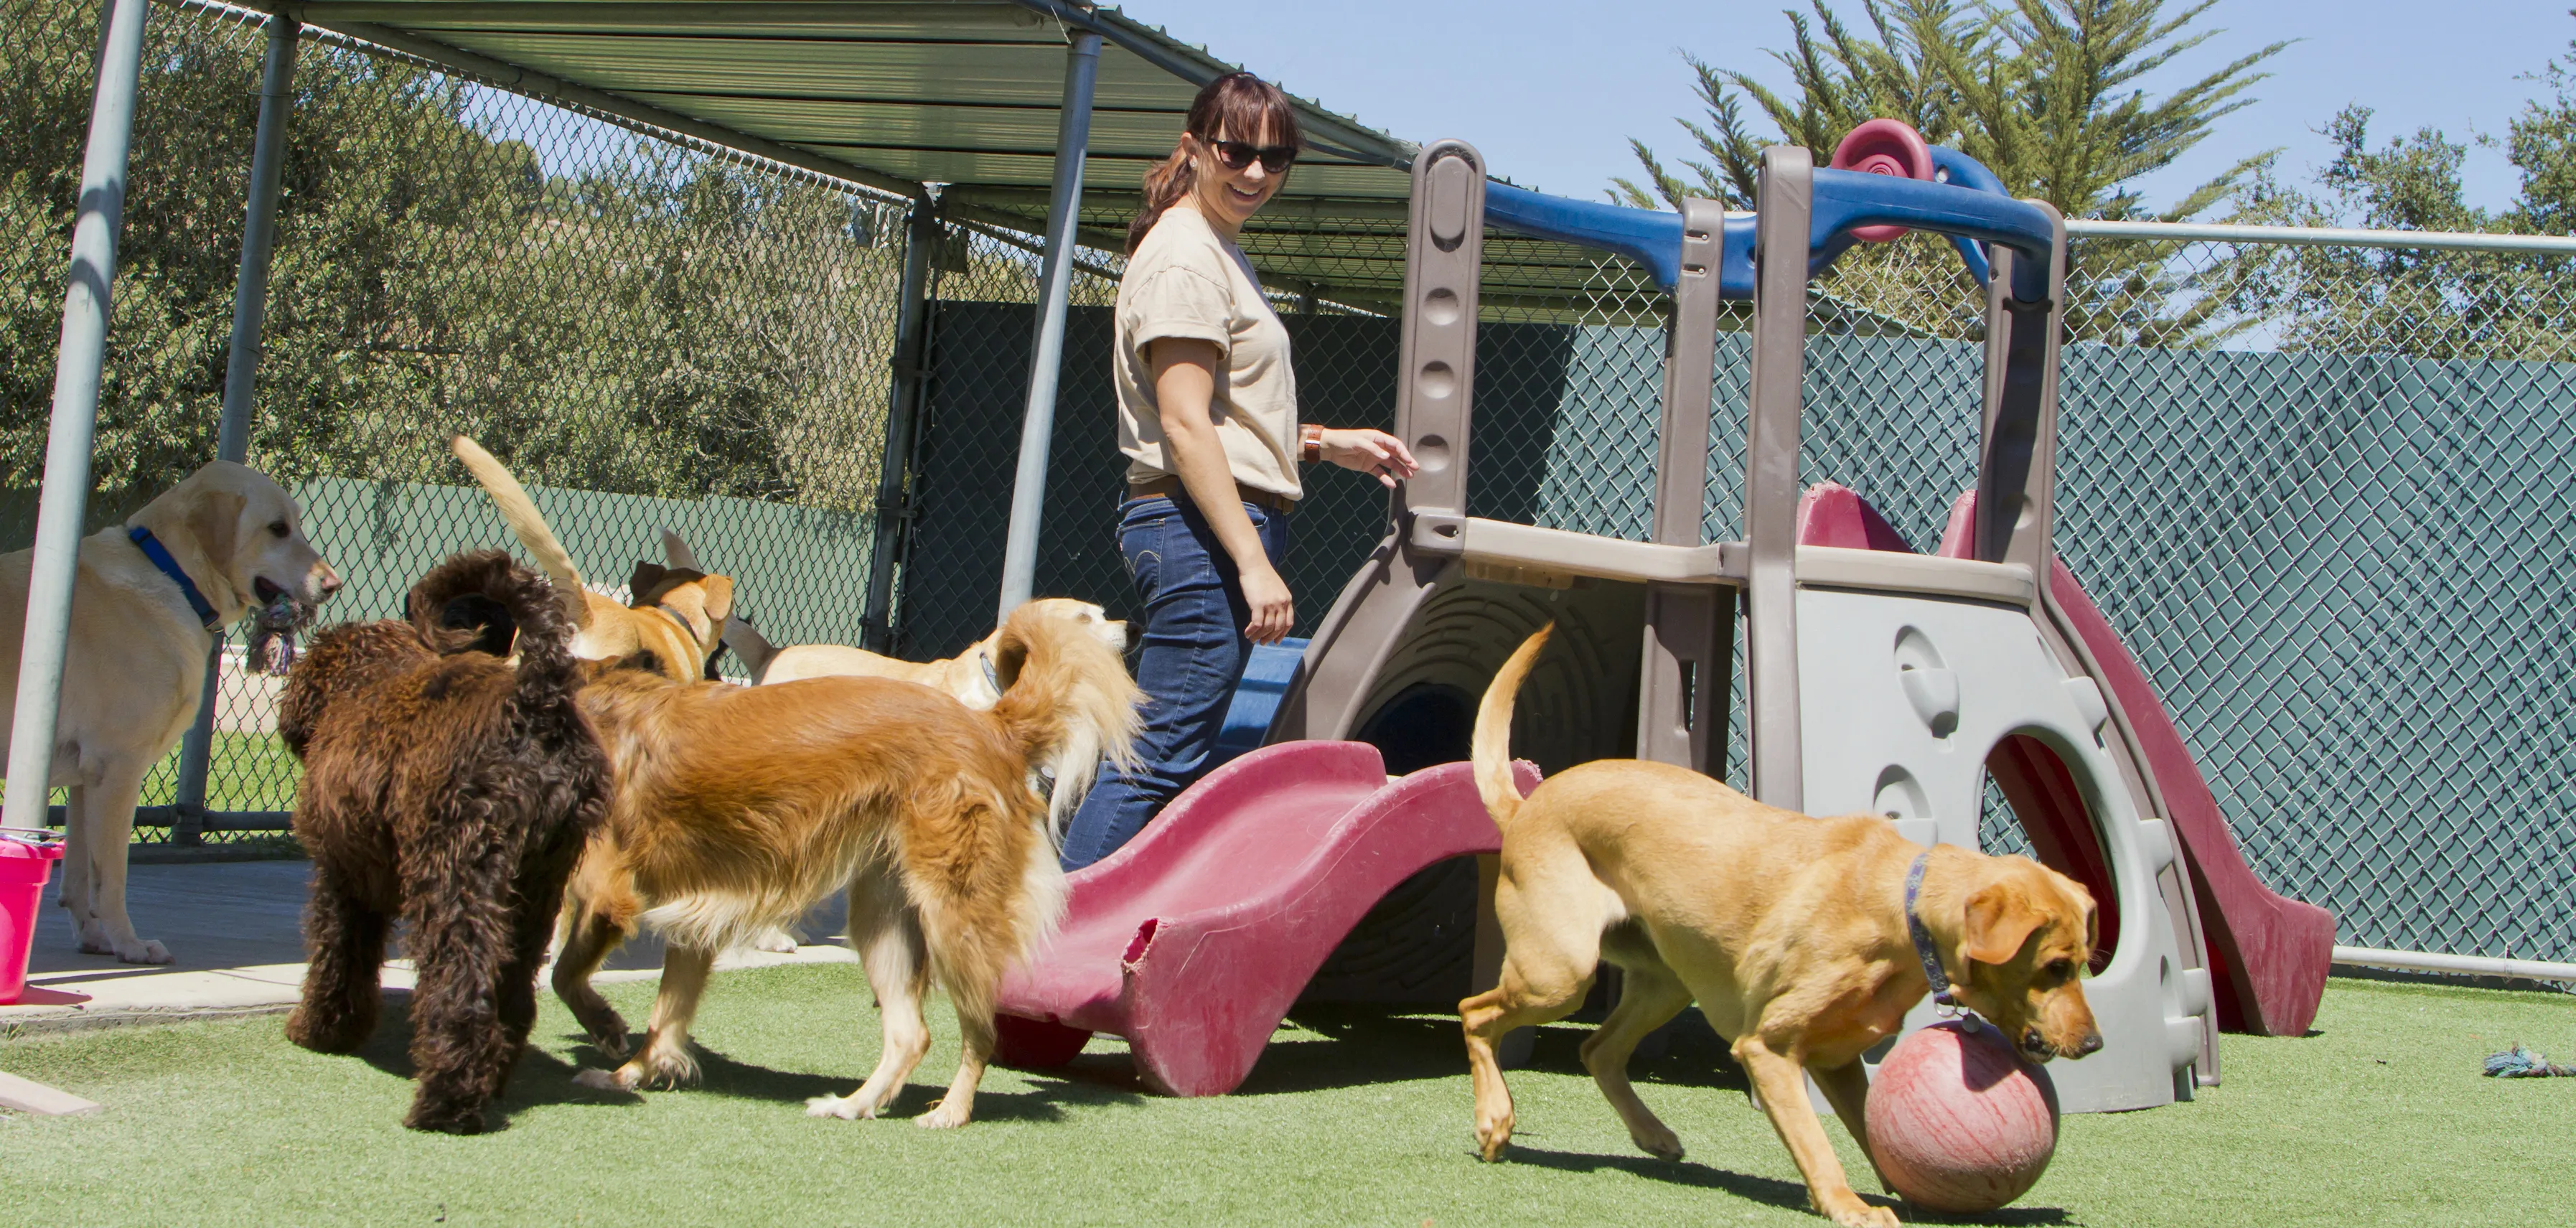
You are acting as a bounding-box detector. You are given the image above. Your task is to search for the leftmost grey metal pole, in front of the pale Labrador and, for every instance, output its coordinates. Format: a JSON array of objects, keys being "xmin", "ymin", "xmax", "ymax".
[{"xmin": 0, "ymin": 0, "xmax": 147, "ymax": 834}]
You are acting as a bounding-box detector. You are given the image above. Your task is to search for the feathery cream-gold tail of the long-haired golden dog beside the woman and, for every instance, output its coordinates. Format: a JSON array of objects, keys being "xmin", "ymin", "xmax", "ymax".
[{"xmin": 992, "ymin": 605, "xmax": 1144, "ymax": 842}]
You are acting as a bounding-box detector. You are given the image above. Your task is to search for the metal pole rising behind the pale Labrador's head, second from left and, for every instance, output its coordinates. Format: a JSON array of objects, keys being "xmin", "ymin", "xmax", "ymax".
[{"xmin": 170, "ymin": 13, "xmax": 304, "ymax": 845}]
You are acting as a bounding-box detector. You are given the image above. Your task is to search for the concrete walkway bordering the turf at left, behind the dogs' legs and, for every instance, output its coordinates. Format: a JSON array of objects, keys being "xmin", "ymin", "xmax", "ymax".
[{"xmin": 0, "ymin": 860, "xmax": 858, "ymax": 1035}]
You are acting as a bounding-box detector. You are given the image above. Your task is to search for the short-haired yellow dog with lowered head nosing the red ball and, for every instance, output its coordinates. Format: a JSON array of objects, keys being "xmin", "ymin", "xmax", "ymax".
[{"xmin": 1458, "ymin": 626, "xmax": 2102, "ymax": 1228}]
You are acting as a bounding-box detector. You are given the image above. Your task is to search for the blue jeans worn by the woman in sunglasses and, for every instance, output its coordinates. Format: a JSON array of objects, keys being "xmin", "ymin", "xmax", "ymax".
[{"xmin": 1064, "ymin": 500, "xmax": 1288, "ymax": 870}]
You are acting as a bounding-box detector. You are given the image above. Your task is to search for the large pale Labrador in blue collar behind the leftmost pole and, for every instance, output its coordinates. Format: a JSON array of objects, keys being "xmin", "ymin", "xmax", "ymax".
[{"xmin": 0, "ymin": 461, "xmax": 340, "ymax": 963}]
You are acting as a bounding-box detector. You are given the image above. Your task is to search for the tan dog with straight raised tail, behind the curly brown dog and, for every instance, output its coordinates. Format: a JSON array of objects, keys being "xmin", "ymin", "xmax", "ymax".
[{"xmin": 448, "ymin": 435, "xmax": 734, "ymax": 683}]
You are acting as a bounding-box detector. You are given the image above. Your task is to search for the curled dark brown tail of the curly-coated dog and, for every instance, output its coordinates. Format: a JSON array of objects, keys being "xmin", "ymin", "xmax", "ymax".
[{"xmin": 404, "ymin": 551, "xmax": 580, "ymax": 703}]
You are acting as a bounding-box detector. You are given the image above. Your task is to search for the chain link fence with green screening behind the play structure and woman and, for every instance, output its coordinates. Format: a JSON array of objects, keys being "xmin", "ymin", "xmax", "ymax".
[{"xmin": 901, "ymin": 203, "xmax": 2576, "ymax": 960}]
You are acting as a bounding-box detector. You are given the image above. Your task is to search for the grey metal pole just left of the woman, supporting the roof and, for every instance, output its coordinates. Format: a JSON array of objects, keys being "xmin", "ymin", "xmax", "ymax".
[{"xmin": 1002, "ymin": 31, "xmax": 1100, "ymax": 618}]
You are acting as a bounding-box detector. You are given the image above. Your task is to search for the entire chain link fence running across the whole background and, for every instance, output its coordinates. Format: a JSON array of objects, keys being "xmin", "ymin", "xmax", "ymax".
[{"xmin": 0, "ymin": 0, "xmax": 2576, "ymax": 960}]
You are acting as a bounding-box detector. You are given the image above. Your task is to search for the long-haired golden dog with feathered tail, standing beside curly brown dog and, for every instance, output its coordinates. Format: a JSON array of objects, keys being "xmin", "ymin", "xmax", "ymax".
[{"xmin": 554, "ymin": 605, "xmax": 1144, "ymax": 1128}]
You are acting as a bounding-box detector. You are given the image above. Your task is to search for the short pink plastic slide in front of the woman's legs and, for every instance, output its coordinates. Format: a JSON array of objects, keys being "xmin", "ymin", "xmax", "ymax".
[{"xmin": 997, "ymin": 741, "xmax": 1538, "ymax": 1097}]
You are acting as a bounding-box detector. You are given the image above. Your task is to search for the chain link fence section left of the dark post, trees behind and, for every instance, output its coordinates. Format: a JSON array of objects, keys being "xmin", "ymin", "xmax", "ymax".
[{"xmin": 0, "ymin": 0, "xmax": 904, "ymax": 839}]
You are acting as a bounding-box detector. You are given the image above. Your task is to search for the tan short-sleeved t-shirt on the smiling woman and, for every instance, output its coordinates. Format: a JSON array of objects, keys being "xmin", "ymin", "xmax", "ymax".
[{"xmin": 1118, "ymin": 209, "xmax": 1303, "ymax": 500}]
